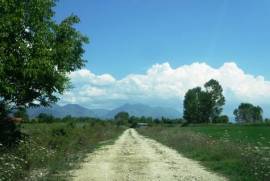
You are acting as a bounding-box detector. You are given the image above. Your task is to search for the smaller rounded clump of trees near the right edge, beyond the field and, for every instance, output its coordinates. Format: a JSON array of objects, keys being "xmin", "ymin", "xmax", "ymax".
[{"xmin": 233, "ymin": 103, "xmax": 263, "ymax": 123}]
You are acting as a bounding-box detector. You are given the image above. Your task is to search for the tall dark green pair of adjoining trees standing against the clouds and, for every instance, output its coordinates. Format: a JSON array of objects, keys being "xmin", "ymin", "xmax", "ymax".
[{"xmin": 184, "ymin": 79, "xmax": 225, "ymax": 123}]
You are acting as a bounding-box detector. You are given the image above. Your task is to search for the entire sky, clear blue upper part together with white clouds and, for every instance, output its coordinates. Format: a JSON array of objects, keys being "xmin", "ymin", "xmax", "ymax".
[{"xmin": 55, "ymin": 0, "xmax": 270, "ymax": 116}]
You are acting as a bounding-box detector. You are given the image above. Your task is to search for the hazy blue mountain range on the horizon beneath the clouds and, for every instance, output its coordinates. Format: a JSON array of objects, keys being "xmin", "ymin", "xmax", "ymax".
[{"xmin": 27, "ymin": 104, "xmax": 180, "ymax": 119}]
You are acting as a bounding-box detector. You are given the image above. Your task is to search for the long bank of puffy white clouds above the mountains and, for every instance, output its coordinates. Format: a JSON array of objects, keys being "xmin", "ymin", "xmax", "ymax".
[{"xmin": 62, "ymin": 62, "xmax": 270, "ymax": 111}]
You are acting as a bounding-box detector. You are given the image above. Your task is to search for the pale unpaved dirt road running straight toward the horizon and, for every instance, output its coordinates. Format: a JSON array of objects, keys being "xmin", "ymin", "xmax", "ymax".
[{"xmin": 72, "ymin": 129, "xmax": 226, "ymax": 181}]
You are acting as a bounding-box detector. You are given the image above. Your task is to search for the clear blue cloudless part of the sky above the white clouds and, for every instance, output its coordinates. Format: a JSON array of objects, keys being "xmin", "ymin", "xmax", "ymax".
[{"xmin": 56, "ymin": 0, "xmax": 270, "ymax": 79}]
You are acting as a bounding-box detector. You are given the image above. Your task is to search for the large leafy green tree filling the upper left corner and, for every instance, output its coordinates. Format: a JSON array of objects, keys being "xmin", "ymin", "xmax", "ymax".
[{"xmin": 0, "ymin": 0, "xmax": 88, "ymax": 115}]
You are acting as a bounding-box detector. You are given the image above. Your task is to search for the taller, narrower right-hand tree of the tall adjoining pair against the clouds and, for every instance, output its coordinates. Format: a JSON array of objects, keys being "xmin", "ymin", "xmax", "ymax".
[{"xmin": 204, "ymin": 79, "xmax": 225, "ymax": 122}]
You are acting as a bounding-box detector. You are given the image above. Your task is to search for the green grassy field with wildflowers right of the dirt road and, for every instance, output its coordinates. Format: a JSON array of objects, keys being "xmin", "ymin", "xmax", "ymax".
[{"xmin": 138, "ymin": 125, "xmax": 270, "ymax": 180}]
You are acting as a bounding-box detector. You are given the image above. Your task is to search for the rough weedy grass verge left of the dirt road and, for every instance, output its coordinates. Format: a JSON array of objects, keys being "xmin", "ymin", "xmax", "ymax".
[{"xmin": 0, "ymin": 122, "xmax": 123, "ymax": 181}]
